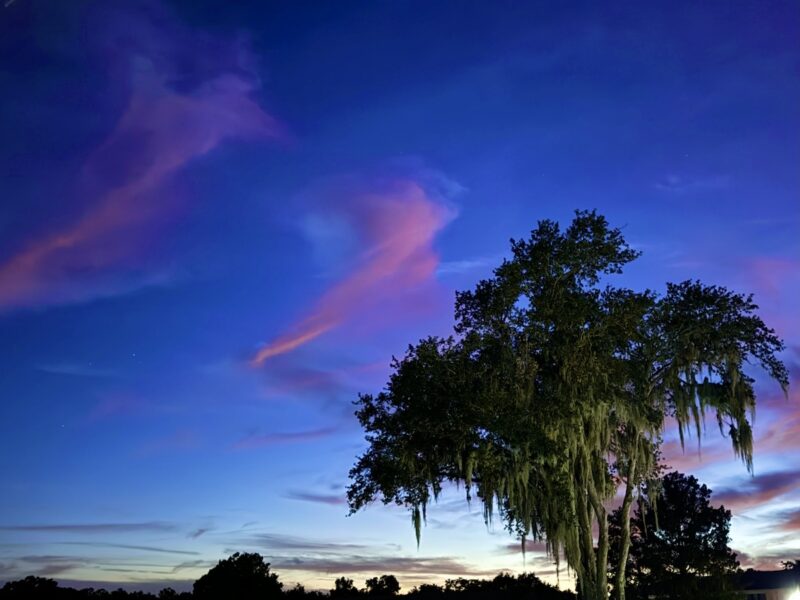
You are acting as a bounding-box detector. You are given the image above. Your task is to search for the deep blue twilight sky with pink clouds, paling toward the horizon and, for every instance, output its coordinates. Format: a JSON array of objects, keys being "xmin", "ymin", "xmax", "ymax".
[{"xmin": 0, "ymin": 0, "xmax": 800, "ymax": 589}]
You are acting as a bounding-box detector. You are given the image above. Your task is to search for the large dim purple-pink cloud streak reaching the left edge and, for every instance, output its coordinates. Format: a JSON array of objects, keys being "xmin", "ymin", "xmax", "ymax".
[{"xmin": 0, "ymin": 2, "xmax": 283, "ymax": 312}]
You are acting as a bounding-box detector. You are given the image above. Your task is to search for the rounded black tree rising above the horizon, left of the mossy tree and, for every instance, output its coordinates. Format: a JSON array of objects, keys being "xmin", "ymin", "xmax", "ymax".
[{"xmin": 194, "ymin": 552, "xmax": 283, "ymax": 600}]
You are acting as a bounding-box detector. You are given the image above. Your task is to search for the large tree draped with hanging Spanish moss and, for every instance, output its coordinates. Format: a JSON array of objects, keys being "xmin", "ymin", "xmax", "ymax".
[{"xmin": 348, "ymin": 212, "xmax": 788, "ymax": 600}]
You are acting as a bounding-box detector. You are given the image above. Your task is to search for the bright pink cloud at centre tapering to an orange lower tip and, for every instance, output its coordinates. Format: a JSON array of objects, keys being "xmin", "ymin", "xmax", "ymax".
[{"xmin": 251, "ymin": 178, "xmax": 454, "ymax": 367}]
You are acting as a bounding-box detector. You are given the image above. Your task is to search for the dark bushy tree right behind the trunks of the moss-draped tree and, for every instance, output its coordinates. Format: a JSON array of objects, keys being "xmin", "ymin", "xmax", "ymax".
[{"xmin": 610, "ymin": 472, "xmax": 739, "ymax": 599}]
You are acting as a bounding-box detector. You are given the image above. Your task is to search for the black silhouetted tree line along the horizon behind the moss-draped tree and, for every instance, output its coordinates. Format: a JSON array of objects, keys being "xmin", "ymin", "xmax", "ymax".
[{"xmin": 0, "ymin": 472, "xmax": 800, "ymax": 600}]
